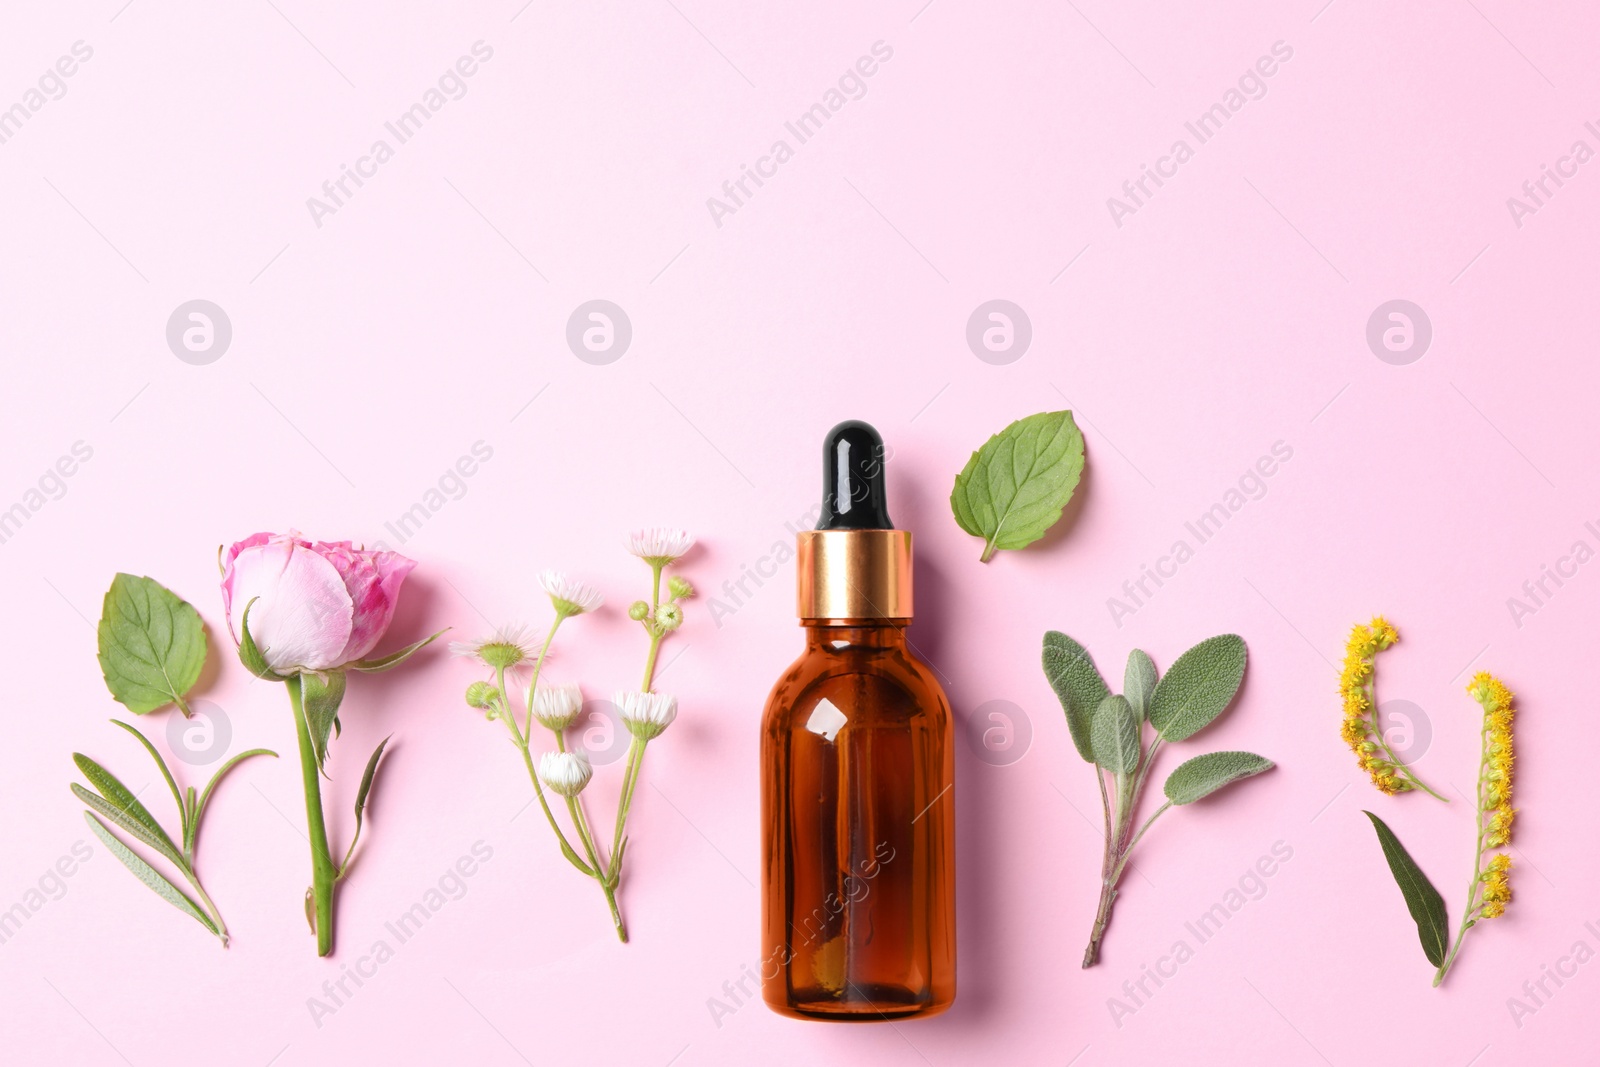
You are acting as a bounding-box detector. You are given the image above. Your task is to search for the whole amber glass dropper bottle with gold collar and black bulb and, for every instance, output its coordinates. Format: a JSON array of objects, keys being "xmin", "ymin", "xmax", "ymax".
[{"xmin": 762, "ymin": 422, "xmax": 955, "ymax": 1021}]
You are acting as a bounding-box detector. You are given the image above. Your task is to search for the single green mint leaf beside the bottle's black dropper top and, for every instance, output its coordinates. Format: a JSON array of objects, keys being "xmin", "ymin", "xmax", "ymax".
[{"xmin": 950, "ymin": 411, "xmax": 1083, "ymax": 563}]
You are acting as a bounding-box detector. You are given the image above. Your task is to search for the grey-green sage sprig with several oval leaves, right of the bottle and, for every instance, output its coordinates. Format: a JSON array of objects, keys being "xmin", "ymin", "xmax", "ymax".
[{"xmin": 1043, "ymin": 630, "xmax": 1274, "ymax": 968}]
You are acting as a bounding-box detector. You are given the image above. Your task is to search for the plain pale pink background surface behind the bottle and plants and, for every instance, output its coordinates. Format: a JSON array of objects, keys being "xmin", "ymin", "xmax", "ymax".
[{"xmin": 0, "ymin": 0, "xmax": 1600, "ymax": 1065}]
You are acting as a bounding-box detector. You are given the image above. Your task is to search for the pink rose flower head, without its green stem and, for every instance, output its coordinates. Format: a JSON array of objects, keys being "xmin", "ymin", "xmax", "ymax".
[{"xmin": 222, "ymin": 533, "xmax": 416, "ymax": 673}]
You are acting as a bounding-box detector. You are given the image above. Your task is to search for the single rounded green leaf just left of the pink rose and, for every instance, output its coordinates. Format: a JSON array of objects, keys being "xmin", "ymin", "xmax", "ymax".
[{"xmin": 98, "ymin": 574, "xmax": 205, "ymax": 715}]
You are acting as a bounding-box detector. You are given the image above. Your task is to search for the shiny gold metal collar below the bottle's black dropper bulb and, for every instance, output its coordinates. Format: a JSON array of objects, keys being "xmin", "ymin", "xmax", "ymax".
[{"xmin": 795, "ymin": 530, "xmax": 912, "ymax": 619}]
